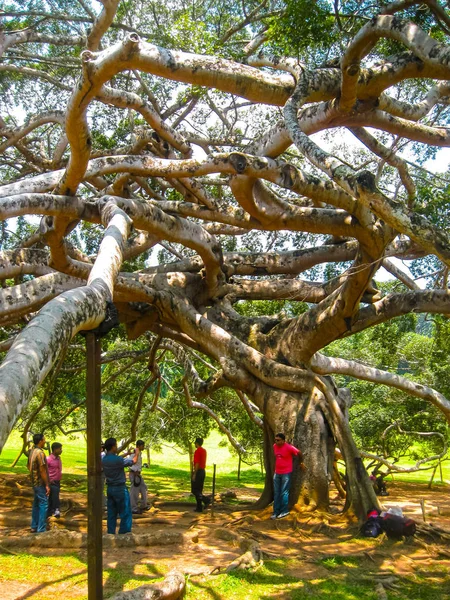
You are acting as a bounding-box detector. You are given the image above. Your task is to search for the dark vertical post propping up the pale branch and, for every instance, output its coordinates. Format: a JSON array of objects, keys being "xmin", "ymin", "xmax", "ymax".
[{"xmin": 86, "ymin": 332, "xmax": 103, "ymax": 600}]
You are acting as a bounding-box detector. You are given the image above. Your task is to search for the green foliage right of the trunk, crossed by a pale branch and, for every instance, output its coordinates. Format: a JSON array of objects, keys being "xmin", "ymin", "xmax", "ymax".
[{"xmin": 327, "ymin": 308, "xmax": 450, "ymax": 461}]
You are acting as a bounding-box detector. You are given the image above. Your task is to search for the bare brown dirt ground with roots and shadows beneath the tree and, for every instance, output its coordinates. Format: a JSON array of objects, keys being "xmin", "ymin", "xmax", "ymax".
[{"xmin": 0, "ymin": 475, "xmax": 450, "ymax": 600}]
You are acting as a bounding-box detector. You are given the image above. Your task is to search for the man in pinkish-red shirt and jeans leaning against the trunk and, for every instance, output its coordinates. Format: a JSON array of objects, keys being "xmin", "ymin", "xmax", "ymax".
[{"xmin": 270, "ymin": 433, "xmax": 302, "ymax": 519}]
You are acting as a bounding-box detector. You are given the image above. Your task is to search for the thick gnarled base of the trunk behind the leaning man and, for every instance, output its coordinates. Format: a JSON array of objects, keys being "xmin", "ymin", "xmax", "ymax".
[{"xmin": 255, "ymin": 378, "xmax": 378, "ymax": 520}]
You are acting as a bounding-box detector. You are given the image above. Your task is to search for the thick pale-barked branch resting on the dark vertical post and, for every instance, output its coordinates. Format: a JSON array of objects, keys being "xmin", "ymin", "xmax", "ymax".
[{"xmin": 0, "ymin": 204, "xmax": 130, "ymax": 447}]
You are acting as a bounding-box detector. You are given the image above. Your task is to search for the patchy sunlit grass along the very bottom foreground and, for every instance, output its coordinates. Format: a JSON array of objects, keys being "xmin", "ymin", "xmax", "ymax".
[{"xmin": 0, "ymin": 553, "xmax": 450, "ymax": 600}]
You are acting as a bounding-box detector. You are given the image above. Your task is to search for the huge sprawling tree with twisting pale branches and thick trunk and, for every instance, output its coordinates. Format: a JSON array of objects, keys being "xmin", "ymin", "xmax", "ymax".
[{"xmin": 0, "ymin": 0, "xmax": 450, "ymax": 516}]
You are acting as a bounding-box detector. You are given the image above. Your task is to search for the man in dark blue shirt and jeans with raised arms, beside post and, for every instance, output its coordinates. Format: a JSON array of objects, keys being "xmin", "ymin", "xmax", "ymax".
[{"xmin": 102, "ymin": 438, "xmax": 136, "ymax": 534}]
